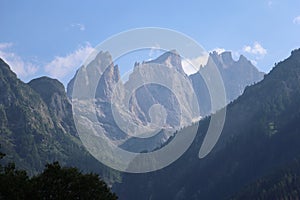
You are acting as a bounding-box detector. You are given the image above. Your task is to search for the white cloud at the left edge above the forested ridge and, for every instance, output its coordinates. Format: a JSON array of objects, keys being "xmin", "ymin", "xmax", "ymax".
[{"xmin": 0, "ymin": 43, "xmax": 38, "ymax": 79}]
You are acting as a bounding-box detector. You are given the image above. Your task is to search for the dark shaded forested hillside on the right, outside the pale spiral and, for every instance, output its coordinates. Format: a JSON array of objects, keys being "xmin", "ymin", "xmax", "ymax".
[{"xmin": 115, "ymin": 49, "xmax": 300, "ymax": 199}]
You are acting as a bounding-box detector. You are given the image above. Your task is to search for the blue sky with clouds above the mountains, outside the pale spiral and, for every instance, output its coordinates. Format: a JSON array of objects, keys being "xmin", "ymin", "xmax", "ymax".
[{"xmin": 0, "ymin": 0, "xmax": 300, "ymax": 85}]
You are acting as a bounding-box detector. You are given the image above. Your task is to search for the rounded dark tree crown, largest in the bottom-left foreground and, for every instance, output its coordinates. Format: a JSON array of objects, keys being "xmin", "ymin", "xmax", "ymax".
[{"xmin": 30, "ymin": 162, "xmax": 117, "ymax": 200}]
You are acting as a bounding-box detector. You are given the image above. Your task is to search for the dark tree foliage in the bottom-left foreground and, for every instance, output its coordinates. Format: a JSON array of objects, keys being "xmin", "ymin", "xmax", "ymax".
[{"xmin": 0, "ymin": 154, "xmax": 117, "ymax": 200}]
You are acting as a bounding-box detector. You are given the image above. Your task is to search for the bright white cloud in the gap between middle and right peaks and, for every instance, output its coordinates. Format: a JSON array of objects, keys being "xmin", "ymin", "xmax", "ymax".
[{"xmin": 181, "ymin": 53, "xmax": 209, "ymax": 75}]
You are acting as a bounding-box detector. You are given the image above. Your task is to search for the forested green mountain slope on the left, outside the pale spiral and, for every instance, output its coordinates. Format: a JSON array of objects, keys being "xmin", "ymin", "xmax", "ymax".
[{"xmin": 0, "ymin": 59, "xmax": 118, "ymax": 182}]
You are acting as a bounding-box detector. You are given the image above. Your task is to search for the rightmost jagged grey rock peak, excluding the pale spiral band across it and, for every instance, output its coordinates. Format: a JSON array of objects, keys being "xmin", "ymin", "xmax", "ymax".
[{"xmin": 190, "ymin": 52, "xmax": 264, "ymax": 116}]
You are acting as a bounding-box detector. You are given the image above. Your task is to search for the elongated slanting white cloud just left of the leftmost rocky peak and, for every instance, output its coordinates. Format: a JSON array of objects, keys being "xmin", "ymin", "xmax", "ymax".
[{"xmin": 44, "ymin": 44, "xmax": 94, "ymax": 79}]
